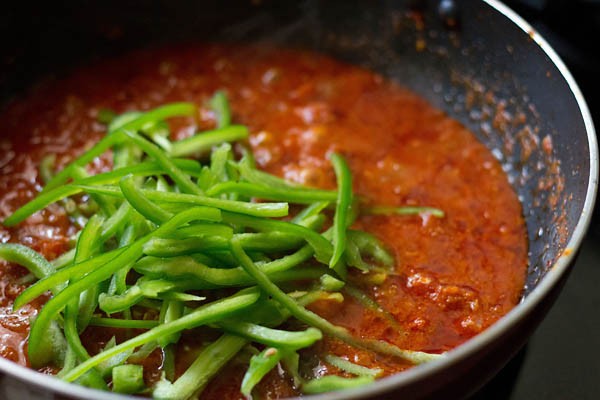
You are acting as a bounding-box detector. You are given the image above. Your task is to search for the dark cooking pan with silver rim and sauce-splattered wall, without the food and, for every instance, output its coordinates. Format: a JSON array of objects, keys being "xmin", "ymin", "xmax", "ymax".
[{"xmin": 0, "ymin": 0, "xmax": 598, "ymax": 399}]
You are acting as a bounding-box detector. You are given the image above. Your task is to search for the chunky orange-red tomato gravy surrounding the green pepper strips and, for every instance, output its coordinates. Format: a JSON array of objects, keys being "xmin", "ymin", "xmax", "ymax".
[{"xmin": 0, "ymin": 45, "xmax": 527, "ymax": 398}]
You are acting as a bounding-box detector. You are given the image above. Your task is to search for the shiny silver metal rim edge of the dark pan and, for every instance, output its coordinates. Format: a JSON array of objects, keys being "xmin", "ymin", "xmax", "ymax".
[{"xmin": 0, "ymin": 0, "xmax": 598, "ymax": 400}]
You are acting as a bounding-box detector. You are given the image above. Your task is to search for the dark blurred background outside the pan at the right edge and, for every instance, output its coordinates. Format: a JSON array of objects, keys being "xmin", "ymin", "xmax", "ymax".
[{"xmin": 471, "ymin": 0, "xmax": 600, "ymax": 400}]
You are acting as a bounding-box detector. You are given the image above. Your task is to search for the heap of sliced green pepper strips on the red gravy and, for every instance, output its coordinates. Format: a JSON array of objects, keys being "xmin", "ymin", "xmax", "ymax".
[{"xmin": 0, "ymin": 92, "xmax": 443, "ymax": 399}]
